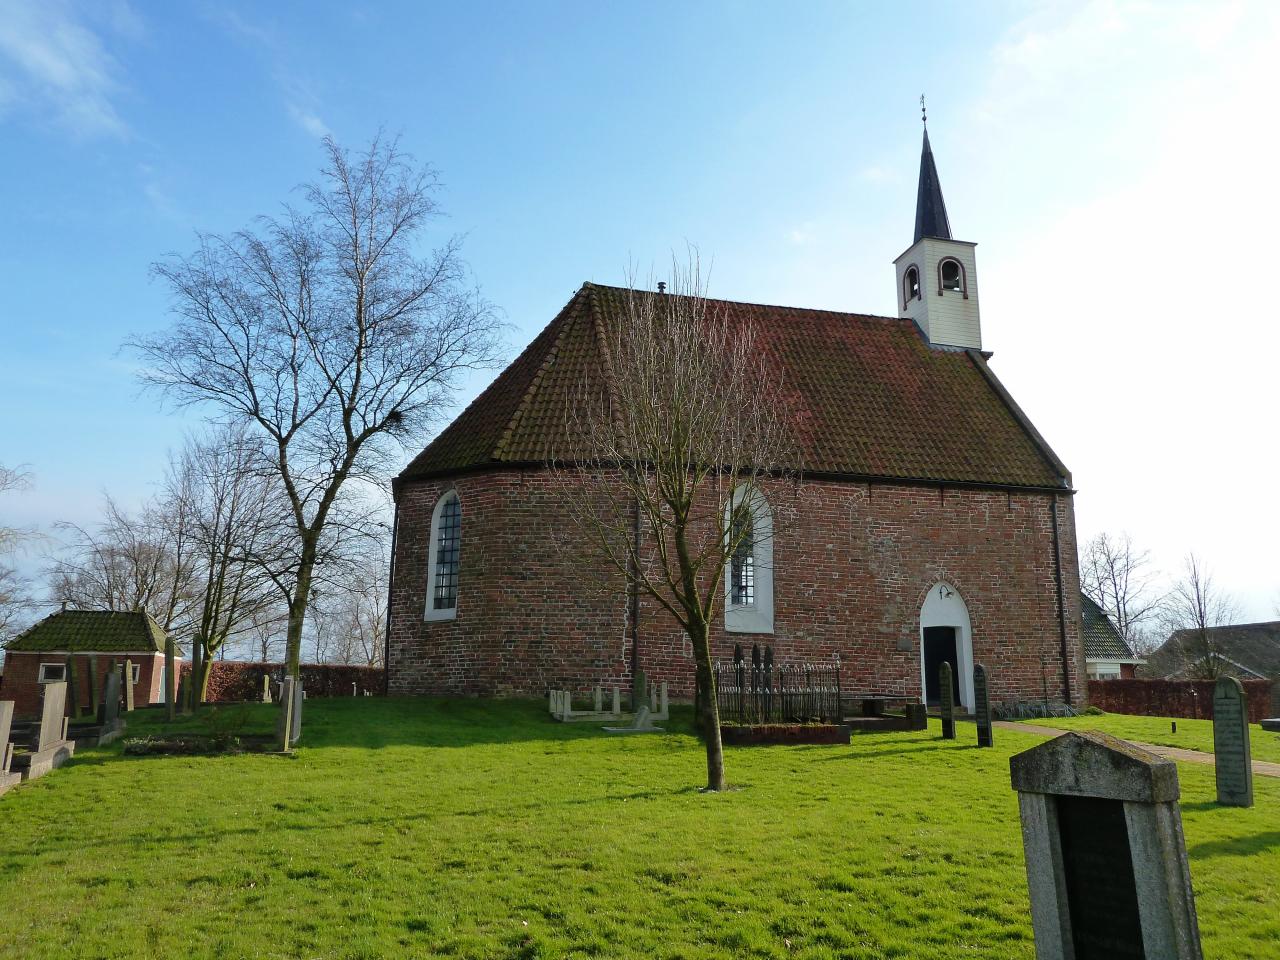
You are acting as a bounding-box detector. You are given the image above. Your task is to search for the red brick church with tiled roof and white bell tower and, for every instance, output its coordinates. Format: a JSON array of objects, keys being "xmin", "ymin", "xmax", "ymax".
[{"xmin": 387, "ymin": 131, "xmax": 1085, "ymax": 708}]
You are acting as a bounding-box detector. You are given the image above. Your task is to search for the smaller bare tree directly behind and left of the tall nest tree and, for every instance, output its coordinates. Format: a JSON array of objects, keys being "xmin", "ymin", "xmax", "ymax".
[{"xmin": 165, "ymin": 428, "xmax": 283, "ymax": 709}]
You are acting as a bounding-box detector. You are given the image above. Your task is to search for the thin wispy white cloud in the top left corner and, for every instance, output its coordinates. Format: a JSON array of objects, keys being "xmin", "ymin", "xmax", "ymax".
[{"xmin": 0, "ymin": 0, "xmax": 132, "ymax": 138}]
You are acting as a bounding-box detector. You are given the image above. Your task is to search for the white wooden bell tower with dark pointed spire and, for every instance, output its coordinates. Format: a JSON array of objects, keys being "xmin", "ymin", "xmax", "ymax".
[{"xmin": 893, "ymin": 97, "xmax": 982, "ymax": 349}]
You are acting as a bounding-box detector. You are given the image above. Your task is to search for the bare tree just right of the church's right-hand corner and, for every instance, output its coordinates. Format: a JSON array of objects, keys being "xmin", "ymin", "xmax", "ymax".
[{"xmin": 1080, "ymin": 532, "xmax": 1165, "ymax": 654}]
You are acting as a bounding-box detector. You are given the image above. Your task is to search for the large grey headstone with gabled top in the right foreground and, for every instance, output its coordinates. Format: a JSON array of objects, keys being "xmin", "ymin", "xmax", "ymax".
[{"xmin": 1009, "ymin": 732, "xmax": 1201, "ymax": 960}]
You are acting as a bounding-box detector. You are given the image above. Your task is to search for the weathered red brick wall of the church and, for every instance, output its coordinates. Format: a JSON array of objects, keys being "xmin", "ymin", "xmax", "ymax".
[{"xmin": 388, "ymin": 470, "xmax": 1085, "ymax": 703}]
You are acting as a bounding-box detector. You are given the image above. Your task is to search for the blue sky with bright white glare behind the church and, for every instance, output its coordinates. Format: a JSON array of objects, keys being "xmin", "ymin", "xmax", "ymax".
[{"xmin": 0, "ymin": 0, "xmax": 1280, "ymax": 618}]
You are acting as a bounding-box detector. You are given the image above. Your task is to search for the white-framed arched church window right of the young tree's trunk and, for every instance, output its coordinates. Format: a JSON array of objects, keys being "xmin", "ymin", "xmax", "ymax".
[{"xmin": 724, "ymin": 488, "xmax": 773, "ymax": 634}]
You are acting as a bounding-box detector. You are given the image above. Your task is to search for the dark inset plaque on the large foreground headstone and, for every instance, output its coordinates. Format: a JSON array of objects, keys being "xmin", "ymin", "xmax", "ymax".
[{"xmin": 1057, "ymin": 796, "xmax": 1147, "ymax": 960}]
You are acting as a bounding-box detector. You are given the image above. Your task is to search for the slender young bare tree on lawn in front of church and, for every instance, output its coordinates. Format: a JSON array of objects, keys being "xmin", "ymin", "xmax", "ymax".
[{"xmin": 553, "ymin": 257, "xmax": 799, "ymax": 790}]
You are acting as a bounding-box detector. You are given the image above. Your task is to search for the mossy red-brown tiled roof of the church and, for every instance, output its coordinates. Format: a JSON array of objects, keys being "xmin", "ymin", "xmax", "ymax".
[{"xmin": 399, "ymin": 283, "xmax": 1070, "ymax": 489}]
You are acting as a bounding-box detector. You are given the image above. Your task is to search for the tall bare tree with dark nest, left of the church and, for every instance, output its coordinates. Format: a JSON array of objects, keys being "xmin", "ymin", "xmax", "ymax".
[{"xmin": 132, "ymin": 138, "xmax": 498, "ymax": 676}]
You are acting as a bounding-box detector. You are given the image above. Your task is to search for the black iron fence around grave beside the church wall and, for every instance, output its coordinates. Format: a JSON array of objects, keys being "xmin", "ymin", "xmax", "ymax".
[{"xmin": 714, "ymin": 644, "xmax": 841, "ymax": 723}]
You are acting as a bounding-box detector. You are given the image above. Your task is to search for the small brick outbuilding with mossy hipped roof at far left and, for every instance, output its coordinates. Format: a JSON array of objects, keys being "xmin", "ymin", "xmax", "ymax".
[{"xmin": 0, "ymin": 611, "xmax": 177, "ymax": 717}]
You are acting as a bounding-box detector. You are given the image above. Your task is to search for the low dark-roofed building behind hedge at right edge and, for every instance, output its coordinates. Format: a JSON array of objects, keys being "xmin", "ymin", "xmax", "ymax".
[{"xmin": 1143, "ymin": 621, "xmax": 1280, "ymax": 680}]
